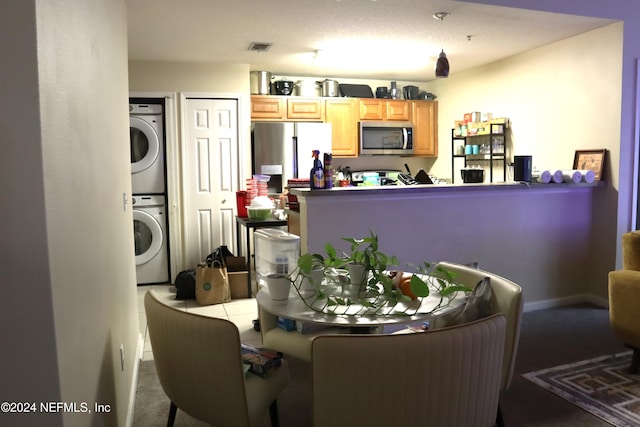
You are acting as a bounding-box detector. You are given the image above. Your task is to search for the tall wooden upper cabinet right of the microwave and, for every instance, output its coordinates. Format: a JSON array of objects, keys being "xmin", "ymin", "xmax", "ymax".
[{"xmin": 411, "ymin": 101, "xmax": 438, "ymax": 157}]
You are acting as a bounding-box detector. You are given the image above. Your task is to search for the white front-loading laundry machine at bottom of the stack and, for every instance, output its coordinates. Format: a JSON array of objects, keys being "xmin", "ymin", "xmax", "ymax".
[{"xmin": 132, "ymin": 195, "xmax": 169, "ymax": 285}]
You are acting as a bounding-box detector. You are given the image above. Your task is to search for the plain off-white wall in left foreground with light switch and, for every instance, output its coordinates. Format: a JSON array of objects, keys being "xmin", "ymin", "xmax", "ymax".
[{"xmin": 0, "ymin": 0, "xmax": 139, "ymax": 426}]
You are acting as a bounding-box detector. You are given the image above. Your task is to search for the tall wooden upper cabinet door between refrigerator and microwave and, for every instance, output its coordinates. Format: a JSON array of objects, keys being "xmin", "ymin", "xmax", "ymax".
[{"xmin": 325, "ymin": 98, "xmax": 359, "ymax": 157}]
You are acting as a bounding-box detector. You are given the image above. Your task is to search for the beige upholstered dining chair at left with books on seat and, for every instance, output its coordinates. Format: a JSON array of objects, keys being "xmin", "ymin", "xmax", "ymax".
[{"xmin": 144, "ymin": 290, "xmax": 289, "ymax": 427}]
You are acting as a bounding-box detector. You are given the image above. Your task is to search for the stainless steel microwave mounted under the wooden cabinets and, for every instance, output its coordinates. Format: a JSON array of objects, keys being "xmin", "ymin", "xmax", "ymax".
[{"xmin": 360, "ymin": 121, "xmax": 413, "ymax": 156}]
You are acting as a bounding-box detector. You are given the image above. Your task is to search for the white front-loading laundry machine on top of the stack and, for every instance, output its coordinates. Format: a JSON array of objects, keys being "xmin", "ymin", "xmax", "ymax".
[{"xmin": 129, "ymin": 104, "xmax": 165, "ymax": 194}]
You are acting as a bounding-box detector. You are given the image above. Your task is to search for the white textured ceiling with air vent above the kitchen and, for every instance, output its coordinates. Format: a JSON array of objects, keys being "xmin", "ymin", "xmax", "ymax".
[{"xmin": 127, "ymin": 0, "xmax": 613, "ymax": 81}]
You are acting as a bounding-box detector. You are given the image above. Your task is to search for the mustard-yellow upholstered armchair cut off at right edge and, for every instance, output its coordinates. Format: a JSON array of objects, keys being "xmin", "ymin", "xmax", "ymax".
[{"xmin": 609, "ymin": 231, "xmax": 640, "ymax": 374}]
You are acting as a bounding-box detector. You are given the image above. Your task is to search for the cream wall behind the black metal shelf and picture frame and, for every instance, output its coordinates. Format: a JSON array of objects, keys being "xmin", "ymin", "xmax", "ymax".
[{"xmin": 432, "ymin": 23, "xmax": 623, "ymax": 188}]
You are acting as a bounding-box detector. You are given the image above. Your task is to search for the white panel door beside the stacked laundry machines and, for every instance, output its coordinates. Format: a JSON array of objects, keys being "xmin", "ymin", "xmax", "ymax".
[{"xmin": 182, "ymin": 99, "xmax": 238, "ymax": 267}]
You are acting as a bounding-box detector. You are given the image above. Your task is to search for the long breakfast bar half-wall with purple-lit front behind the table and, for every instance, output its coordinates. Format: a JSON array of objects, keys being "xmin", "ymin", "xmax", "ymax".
[{"xmin": 289, "ymin": 182, "xmax": 615, "ymax": 310}]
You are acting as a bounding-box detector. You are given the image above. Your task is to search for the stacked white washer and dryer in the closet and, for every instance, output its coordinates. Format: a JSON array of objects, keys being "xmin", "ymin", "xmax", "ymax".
[{"xmin": 129, "ymin": 99, "xmax": 169, "ymax": 285}]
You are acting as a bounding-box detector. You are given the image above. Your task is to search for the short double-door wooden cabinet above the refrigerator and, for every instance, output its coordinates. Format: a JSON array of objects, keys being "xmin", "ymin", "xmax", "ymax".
[{"xmin": 251, "ymin": 95, "xmax": 324, "ymax": 122}]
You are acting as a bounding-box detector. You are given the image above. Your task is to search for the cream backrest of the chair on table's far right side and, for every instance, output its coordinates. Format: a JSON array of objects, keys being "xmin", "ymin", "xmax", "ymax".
[{"xmin": 438, "ymin": 262, "xmax": 524, "ymax": 390}]
